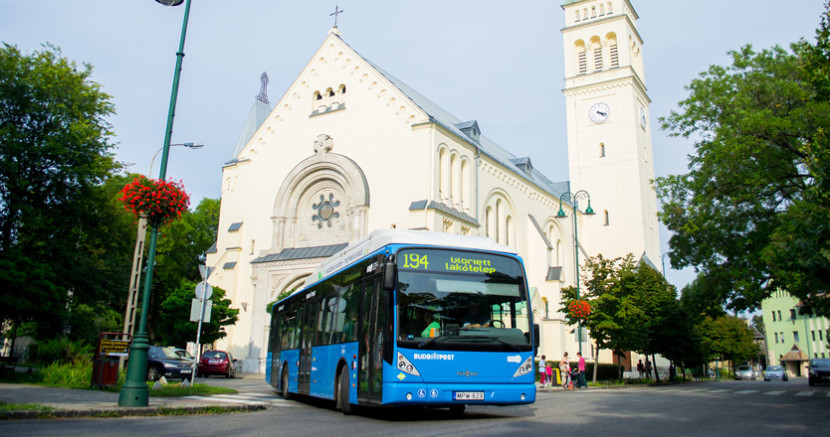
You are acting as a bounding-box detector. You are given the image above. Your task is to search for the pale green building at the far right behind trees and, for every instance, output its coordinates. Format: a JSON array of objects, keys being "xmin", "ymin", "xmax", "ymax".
[{"xmin": 761, "ymin": 290, "xmax": 830, "ymax": 376}]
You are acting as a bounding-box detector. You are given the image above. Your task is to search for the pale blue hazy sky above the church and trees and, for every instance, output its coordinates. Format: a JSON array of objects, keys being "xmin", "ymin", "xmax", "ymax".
[{"xmin": 0, "ymin": 0, "xmax": 825, "ymax": 289}]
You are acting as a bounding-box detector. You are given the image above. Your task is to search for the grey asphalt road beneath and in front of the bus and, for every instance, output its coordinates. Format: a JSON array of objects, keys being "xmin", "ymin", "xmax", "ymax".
[{"xmin": 0, "ymin": 379, "xmax": 830, "ymax": 437}]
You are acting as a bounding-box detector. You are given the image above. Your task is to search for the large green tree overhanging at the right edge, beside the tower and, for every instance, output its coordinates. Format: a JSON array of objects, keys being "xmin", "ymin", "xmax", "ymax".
[{"xmin": 655, "ymin": 2, "xmax": 830, "ymax": 315}]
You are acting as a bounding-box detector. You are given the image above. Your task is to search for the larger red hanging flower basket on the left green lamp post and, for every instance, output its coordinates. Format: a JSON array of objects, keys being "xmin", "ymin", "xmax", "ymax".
[{"xmin": 121, "ymin": 175, "xmax": 190, "ymax": 227}]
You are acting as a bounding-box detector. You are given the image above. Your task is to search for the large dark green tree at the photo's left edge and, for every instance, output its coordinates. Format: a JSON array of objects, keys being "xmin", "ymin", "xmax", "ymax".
[{"xmin": 0, "ymin": 44, "xmax": 120, "ymax": 337}]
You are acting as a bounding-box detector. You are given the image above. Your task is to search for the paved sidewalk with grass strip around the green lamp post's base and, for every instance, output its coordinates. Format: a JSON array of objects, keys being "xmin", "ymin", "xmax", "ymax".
[{"xmin": 0, "ymin": 374, "xmax": 265, "ymax": 420}]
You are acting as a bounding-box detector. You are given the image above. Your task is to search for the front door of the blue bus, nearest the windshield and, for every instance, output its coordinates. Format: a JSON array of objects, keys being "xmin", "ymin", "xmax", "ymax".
[{"xmin": 357, "ymin": 276, "xmax": 389, "ymax": 403}]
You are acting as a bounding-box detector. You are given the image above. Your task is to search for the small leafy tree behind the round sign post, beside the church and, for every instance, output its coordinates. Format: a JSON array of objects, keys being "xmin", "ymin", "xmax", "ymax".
[{"xmin": 156, "ymin": 280, "xmax": 239, "ymax": 346}]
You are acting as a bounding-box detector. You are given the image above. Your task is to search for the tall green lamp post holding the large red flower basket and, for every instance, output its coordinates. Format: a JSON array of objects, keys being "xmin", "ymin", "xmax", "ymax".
[{"xmin": 118, "ymin": 0, "xmax": 190, "ymax": 407}]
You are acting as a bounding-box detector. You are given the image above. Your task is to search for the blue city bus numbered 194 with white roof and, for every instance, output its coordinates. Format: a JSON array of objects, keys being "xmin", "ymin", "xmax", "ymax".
[{"xmin": 266, "ymin": 230, "xmax": 539, "ymax": 414}]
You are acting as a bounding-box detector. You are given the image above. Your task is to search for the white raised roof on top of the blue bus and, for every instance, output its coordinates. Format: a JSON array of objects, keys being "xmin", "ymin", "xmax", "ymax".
[{"xmin": 305, "ymin": 229, "xmax": 518, "ymax": 287}]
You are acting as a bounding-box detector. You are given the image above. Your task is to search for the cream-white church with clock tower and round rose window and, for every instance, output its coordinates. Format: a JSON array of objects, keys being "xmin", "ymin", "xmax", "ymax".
[{"xmin": 207, "ymin": 0, "xmax": 660, "ymax": 373}]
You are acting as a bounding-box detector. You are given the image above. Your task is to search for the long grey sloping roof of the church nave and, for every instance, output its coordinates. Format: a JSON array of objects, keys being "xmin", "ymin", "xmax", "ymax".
[{"xmin": 354, "ymin": 39, "xmax": 570, "ymax": 204}]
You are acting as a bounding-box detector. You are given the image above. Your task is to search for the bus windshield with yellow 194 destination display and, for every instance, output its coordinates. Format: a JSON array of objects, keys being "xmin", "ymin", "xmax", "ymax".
[{"xmin": 397, "ymin": 249, "xmax": 531, "ymax": 351}]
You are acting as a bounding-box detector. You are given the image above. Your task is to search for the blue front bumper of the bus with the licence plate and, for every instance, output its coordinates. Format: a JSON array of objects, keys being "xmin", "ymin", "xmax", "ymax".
[{"xmin": 383, "ymin": 382, "xmax": 536, "ymax": 407}]
